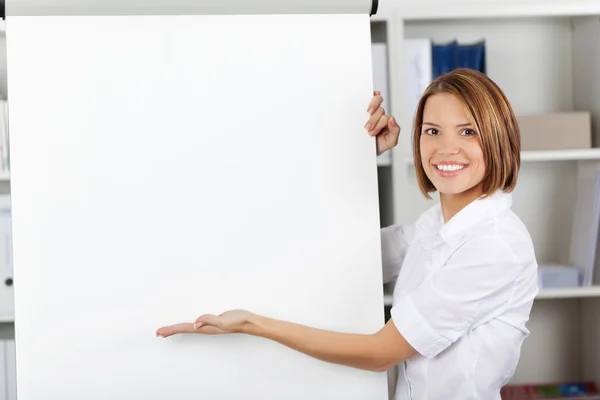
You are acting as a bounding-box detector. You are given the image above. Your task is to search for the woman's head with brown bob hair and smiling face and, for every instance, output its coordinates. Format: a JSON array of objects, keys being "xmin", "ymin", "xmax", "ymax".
[{"xmin": 413, "ymin": 69, "xmax": 520, "ymax": 220}]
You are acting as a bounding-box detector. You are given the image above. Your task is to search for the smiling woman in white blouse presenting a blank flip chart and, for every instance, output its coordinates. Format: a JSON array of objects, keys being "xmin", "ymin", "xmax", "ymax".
[{"xmin": 157, "ymin": 69, "xmax": 538, "ymax": 400}]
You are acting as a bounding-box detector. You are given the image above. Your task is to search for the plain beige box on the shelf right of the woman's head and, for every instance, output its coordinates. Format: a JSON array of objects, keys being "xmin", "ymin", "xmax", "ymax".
[{"xmin": 517, "ymin": 111, "xmax": 592, "ymax": 151}]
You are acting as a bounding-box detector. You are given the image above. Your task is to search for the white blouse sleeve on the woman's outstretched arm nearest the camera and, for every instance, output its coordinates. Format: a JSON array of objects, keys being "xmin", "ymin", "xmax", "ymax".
[{"xmin": 391, "ymin": 237, "xmax": 523, "ymax": 357}]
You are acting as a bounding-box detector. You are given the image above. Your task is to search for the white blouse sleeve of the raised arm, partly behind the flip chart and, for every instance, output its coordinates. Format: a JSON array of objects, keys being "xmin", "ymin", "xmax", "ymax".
[{"xmin": 381, "ymin": 225, "xmax": 415, "ymax": 283}]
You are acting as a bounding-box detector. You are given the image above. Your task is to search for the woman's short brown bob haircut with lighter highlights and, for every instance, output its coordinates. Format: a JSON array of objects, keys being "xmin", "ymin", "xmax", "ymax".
[{"xmin": 413, "ymin": 68, "xmax": 521, "ymax": 199}]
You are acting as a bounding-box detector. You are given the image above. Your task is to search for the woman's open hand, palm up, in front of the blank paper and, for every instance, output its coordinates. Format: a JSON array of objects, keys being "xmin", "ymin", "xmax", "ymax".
[{"xmin": 156, "ymin": 310, "xmax": 252, "ymax": 338}]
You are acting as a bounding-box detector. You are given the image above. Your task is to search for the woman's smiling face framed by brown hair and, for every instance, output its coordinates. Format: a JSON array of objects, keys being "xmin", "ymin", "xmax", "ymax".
[{"xmin": 420, "ymin": 93, "xmax": 485, "ymax": 200}]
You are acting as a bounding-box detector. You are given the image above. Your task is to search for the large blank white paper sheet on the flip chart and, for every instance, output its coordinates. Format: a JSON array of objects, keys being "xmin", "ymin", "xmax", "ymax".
[{"xmin": 7, "ymin": 15, "xmax": 387, "ymax": 400}]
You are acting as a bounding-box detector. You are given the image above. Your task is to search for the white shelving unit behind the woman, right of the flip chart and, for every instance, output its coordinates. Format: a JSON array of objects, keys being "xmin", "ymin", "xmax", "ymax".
[{"xmin": 374, "ymin": 0, "xmax": 600, "ymax": 392}]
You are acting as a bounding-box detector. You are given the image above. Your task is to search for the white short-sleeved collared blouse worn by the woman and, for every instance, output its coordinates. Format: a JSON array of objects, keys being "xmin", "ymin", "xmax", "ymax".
[{"xmin": 381, "ymin": 191, "xmax": 538, "ymax": 400}]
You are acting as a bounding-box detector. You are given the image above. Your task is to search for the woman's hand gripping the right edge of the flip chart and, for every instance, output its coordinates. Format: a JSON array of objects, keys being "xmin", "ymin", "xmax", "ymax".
[{"xmin": 365, "ymin": 91, "xmax": 400, "ymax": 156}]
